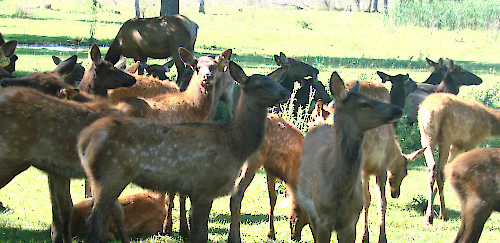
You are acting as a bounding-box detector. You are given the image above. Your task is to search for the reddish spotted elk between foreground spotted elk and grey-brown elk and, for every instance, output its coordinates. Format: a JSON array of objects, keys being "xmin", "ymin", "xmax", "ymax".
[{"xmin": 228, "ymin": 113, "xmax": 307, "ymax": 242}]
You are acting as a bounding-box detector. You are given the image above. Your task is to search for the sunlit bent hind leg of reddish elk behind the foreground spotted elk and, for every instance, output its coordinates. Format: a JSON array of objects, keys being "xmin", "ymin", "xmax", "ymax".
[{"xmin": 228, "ymin": 159, "xmax": 260, "ymax": 242}]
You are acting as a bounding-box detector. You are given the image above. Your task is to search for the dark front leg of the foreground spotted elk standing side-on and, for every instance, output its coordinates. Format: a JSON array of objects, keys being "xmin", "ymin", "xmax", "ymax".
[{"xmin": 189, "ymin": 197, "xmax": 213, "ymax": 242}]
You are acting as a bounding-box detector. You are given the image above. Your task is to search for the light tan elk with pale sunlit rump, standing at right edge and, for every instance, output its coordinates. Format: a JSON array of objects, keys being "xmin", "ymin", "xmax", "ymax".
[{"xmin": 418, "ymin": 93, "xmax": 500, "ymax": 224}]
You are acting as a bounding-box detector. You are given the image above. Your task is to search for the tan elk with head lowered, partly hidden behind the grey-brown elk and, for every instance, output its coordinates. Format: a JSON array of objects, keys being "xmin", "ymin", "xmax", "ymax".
[{"xmin": 312, "ymin": 81, "xmax": 423, "ymax": 242}]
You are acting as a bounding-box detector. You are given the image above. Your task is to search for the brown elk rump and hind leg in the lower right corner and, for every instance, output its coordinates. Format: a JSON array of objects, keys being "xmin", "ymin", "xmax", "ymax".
[{"xmin": 445, "ymin": 148, "xmax": 500, "ymax": 243}]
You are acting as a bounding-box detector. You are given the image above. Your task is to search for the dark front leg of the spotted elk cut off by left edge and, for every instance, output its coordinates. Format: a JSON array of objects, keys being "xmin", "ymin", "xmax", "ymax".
[{"xmin": 49, "ymin": 174, "xmax": 73, "ymax": 243}]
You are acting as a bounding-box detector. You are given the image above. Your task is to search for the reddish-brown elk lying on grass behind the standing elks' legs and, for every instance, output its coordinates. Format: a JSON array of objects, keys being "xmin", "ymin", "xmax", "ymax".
[{"xmin": 57, "ymin": 191, "xmax": 167, "ymax": 240}]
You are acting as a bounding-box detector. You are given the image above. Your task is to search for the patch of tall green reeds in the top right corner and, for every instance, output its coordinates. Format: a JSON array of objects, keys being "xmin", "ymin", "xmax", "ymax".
[{"xmin": 389, "ymin": 0, "xmax": 500, "ymax": 30}]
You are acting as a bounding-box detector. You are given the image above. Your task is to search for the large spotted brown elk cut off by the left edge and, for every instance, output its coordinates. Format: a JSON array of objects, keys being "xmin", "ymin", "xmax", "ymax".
[{"xmin": 0, "ymin": 87, "xmax": 156, "ymax": 243}]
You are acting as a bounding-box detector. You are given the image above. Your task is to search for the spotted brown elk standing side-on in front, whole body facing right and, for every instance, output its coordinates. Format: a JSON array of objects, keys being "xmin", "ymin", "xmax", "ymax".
[{"xmin": 77, "ymin": 62, "xmax": 290, "ymax": 242}]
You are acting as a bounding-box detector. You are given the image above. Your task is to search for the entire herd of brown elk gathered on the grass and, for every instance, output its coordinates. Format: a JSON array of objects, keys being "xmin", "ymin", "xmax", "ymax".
[{"xmin": 0, "ymin": 27, "xmax": 494, "ymax": 243}]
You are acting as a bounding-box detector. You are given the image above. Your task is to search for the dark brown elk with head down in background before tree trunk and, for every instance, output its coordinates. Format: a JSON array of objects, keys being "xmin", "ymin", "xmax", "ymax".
[{"xmin": 104, "ymin": 15, "xmax": 198, "ymax": 90}]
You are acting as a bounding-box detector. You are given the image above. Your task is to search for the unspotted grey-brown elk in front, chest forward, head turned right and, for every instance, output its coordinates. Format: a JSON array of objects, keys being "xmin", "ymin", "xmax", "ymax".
[{"xmin": 296, "ymin": 72, "xmax": 403, "ymax": 242}]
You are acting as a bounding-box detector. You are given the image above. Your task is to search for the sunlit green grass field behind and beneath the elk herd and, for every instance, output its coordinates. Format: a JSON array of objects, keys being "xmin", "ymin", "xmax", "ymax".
[{"xmin": 0, "ymin": 0, "xmax": 500, "ymax": 242}]
